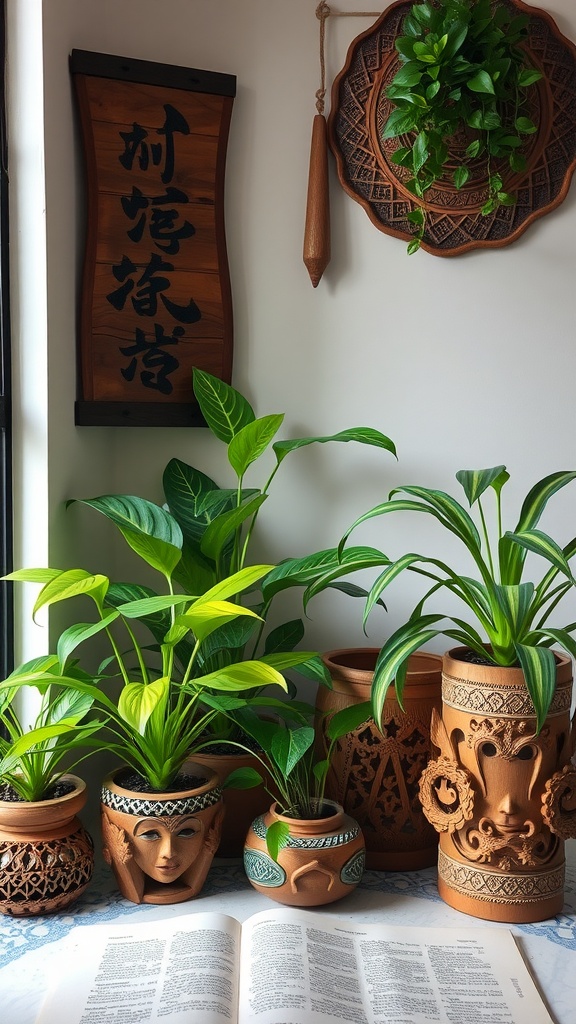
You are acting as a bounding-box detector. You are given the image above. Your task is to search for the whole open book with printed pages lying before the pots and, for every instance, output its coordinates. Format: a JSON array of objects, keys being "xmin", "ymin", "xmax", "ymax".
[{"xmin": 38, "ymin": 907, "xmax": 551, "ymax": 1024}]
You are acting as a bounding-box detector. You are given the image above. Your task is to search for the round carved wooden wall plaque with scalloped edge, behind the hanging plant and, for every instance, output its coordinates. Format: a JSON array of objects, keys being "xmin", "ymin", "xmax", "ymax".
[{"xmin": 328, "ymin": 0, "xmax": 576, "ymax": 256}]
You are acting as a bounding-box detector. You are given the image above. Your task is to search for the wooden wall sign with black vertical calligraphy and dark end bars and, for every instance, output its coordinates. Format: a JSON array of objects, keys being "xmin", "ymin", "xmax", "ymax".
[{"xmin": 70, "ymin": 50, "xmax": 236, "ymax": 426}]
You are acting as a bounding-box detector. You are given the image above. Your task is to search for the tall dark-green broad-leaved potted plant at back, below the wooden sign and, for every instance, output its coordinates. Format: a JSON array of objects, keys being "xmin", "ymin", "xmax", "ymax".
[{"xmin": 70, "ymin": 370, "xmax": 396, "ymax": 855}]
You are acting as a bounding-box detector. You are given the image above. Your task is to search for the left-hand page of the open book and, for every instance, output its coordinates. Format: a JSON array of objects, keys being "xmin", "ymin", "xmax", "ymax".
[{"xmin": 37, "ymin": 913, "xmax": 241, "ymax": 1024}]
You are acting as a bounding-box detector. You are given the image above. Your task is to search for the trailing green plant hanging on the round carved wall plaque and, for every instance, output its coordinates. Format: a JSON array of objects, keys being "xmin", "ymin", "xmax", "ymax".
[{"xmin": 382, "ymin": 0, "xmax": 542, "ymax": 253}]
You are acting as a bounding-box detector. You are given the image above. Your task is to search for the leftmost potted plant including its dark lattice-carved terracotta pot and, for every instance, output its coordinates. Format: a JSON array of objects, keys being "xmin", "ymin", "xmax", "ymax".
[{"xmin": 0, "ymin": 656, "xmax": 101, "ymax": 916}]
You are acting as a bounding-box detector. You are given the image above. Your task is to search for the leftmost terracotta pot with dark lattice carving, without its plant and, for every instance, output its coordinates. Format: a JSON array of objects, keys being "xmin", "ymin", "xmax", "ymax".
[{"xmin": 0, "ymin": 774, "xmax": 94, "ymax": 918}]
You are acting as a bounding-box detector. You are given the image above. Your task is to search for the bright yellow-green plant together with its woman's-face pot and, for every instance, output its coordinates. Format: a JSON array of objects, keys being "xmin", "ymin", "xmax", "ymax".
[{"xmin": 3, "ymin": 499, "xmax": 311, "ymax": 903}]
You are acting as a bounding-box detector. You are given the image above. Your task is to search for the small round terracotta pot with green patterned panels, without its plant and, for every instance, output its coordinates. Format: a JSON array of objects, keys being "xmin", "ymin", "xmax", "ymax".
[{"xmin": 244, "ymin": 801, "xmax": 365, "ymax": 906}]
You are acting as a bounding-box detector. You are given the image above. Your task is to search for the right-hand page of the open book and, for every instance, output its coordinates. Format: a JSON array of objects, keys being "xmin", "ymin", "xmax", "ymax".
[{"xmin": 239, "ymin": 909, "xmax": 552, "ymax": 1024}]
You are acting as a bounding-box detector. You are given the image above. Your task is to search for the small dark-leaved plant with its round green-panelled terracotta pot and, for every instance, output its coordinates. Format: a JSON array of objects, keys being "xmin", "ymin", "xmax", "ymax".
[{"xmin": 235, "ymin": 701, "xmax": 370, "ymax": 906}]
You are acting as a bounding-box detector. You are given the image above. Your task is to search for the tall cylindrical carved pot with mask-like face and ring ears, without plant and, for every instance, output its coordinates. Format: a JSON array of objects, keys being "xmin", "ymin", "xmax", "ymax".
[{"xmin": 420, "ymin": 647, "xmax": 576, "ymax": 924}]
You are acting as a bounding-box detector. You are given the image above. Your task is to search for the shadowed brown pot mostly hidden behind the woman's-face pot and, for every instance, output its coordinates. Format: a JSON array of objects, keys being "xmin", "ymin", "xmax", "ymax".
[{"xmin": 195, "ymin": 751, "xmax": 270, "ymax": 857}]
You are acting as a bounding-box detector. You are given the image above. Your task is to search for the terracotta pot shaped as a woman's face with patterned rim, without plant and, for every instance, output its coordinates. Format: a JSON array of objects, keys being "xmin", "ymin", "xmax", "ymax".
[{"xmin": 100, "ymin": 761, "xmax": 224, "ymax": 904}]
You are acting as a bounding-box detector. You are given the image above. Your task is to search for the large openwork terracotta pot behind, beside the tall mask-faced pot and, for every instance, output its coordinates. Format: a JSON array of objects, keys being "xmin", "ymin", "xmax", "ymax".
[{"xmin": 317, "ymin": 647, "xmax": 442, "ymax": 871}]
